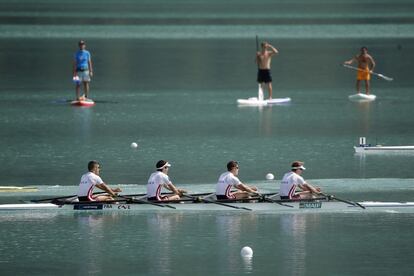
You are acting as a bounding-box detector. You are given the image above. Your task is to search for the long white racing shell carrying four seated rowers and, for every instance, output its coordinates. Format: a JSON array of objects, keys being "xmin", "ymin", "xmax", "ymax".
[{"xmin": 0, "ymin": 198, "xmax": 414, "ymax": 212}]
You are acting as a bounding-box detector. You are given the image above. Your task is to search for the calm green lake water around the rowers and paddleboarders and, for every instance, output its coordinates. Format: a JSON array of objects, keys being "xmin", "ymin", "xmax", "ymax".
[{"xmin": 0, "ymin": 0, "xmax": 414, "ymax": 275}]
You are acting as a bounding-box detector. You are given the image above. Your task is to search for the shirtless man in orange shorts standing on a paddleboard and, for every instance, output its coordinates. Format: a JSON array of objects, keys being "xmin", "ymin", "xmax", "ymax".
[{"xmin": 344, "ymin": 47, "xmax": 375, "ymax": 95}]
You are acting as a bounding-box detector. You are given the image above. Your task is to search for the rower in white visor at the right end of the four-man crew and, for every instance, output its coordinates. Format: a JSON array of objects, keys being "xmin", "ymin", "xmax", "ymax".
[{"xmin": 279, "ymin": 161, "xmax": 321, "ymax": 199}]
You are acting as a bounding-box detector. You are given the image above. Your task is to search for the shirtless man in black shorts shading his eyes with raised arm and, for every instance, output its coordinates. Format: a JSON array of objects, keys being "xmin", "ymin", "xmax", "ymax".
[{"xmin": 256, "ymin": 41, "xmax": 279, "ymax": 100}]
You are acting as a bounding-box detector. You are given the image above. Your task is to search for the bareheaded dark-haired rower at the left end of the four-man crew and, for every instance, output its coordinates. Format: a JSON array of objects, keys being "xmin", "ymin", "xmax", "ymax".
[{"xmin": 78, "ymin": 161, "xmax": 122, "ymax": 201}]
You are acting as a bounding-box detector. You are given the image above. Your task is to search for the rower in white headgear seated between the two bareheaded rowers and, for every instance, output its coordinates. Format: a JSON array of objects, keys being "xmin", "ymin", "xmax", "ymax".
[{"xmin": 147, "ymin": 160, "xmax": 186, "ymax": 201}]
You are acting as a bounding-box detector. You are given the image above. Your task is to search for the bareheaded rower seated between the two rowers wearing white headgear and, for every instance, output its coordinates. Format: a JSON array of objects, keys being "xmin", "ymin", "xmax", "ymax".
[{"xmin": 216, "ymin": 161, "xmax": 257, "ymax": 200}]
